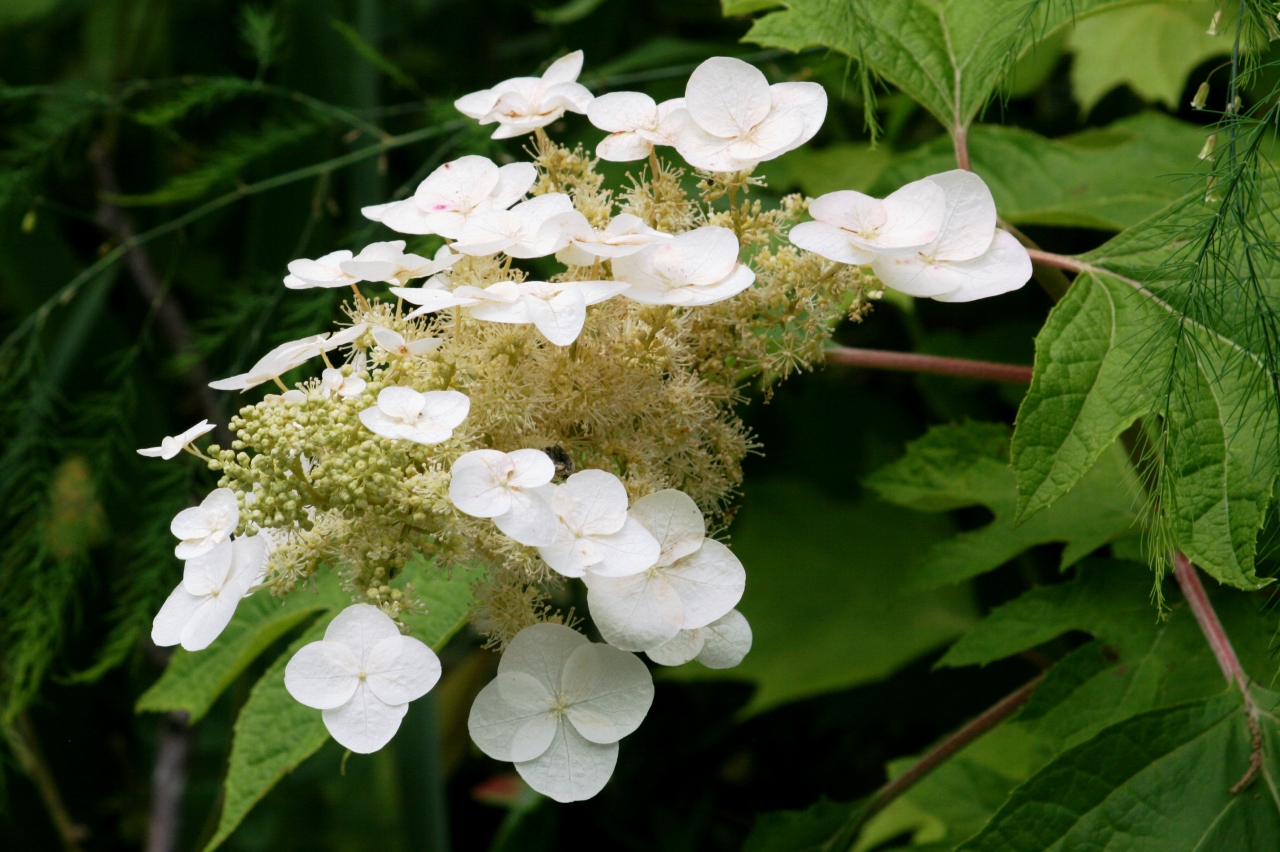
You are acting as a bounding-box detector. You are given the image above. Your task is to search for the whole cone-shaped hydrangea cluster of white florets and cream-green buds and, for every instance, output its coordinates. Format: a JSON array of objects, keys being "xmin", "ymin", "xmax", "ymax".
[{"xmin": 140, "ymin": 52, "xmax": 1030, "ymax": 801}]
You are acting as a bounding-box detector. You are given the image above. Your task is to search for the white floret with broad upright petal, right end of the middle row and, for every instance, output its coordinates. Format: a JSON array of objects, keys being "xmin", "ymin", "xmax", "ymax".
[{"xmin": 613, "ymin": 226, "xmax": 755, "ymax": 306}]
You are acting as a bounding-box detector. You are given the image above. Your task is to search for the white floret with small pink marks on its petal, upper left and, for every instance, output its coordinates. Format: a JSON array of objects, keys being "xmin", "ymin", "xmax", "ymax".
[{"xmin": 361, "ymin": 155, "xmax": 538, "ymax": 235}]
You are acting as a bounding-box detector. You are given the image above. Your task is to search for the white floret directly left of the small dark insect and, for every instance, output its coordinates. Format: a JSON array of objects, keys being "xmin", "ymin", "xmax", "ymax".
[{"xmin": 449, "ymin": 449, "xmax": 557, "ymax": 548}]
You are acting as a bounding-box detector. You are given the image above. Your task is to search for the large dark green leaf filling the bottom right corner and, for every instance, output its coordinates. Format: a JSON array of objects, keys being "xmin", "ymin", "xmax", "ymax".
[{"xmin": 960, "ymin": 688, "xmax": 1280, "ymax": 852}]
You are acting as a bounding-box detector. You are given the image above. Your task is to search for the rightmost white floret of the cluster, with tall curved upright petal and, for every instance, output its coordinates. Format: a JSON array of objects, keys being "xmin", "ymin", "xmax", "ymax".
[{"xmin": 872, "ymin": 169, "xmax": 1032, "ymax": 302}]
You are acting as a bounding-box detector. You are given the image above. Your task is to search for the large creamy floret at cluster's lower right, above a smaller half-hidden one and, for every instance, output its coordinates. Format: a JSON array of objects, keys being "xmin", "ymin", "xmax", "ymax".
[{"xmin": 582, "ymin": 489, "xmax": 746, "ymax": 651}]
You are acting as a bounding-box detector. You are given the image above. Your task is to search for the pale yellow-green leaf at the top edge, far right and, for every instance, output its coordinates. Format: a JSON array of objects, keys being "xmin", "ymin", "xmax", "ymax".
[{"xmin": 1068, "ymin": 0, "xmax": 1231, "ymax": 113}]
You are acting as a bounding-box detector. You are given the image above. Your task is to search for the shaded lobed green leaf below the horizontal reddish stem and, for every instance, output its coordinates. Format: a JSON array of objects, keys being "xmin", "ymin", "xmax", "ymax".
[{"xmin": 865, "ymin": 422, "xmax": 1139, "ymax": 588}]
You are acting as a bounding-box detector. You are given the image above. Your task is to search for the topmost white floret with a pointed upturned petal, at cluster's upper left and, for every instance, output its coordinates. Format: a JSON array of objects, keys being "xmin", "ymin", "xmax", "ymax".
[{"xmin": 453, "ymin": 50, "xmax": 591, "ymax": 139}]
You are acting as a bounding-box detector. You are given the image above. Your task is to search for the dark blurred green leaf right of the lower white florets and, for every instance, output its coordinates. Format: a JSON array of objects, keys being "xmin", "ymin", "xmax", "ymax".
[{"xmin": 664, "ymin": 481, "xmax": 974, "ymax": 713}]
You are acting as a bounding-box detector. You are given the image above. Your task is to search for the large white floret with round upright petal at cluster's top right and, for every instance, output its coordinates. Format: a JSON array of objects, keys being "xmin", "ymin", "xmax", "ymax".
[{"xmin": 676, "ymin": 56, "xmax": 827, "ymax": 171}]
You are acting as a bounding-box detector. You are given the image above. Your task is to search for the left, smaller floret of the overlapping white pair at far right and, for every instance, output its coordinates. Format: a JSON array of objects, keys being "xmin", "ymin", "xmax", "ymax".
[{"xmin": 791, "ymin": 178, "xmax": 947, "ymax": 266}]
